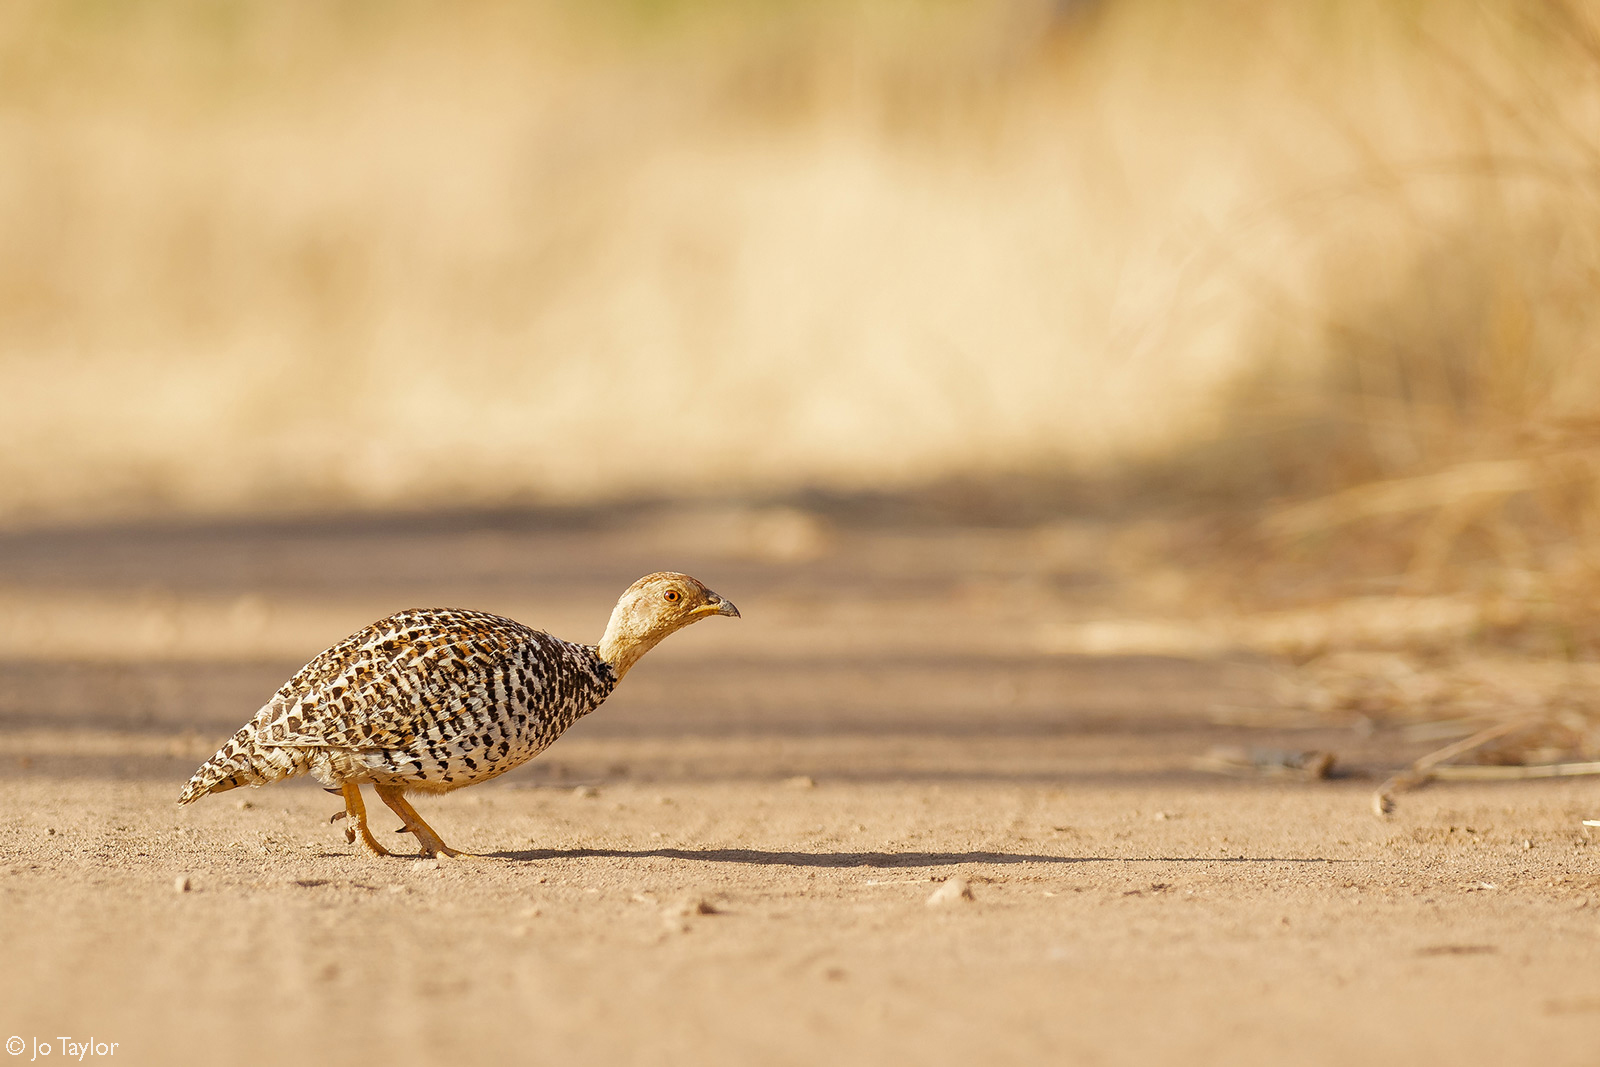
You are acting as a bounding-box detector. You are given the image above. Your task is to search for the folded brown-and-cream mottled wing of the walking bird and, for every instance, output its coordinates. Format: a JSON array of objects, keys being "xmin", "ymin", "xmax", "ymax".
[{"xmin": 256, "ymin": 609, "xmax": 534, "ymax": 752}]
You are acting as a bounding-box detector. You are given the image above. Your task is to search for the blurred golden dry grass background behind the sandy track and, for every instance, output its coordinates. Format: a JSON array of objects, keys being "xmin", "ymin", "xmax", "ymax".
[{"xmin": 9, "ymin": 0, "xmax": 1600, "ymax": 668}]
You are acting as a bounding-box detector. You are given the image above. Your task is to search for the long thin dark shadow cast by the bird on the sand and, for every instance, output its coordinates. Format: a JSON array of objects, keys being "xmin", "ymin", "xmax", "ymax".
[{"xmin": 480, "ymin": 848, "xmax": 1349, "ymax": 867}]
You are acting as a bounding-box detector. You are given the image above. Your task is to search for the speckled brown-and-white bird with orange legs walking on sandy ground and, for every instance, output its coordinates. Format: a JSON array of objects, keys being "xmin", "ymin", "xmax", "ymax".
[{"xmin": 178, "ymin": 571, "xmax": 739, "ymax": 857}]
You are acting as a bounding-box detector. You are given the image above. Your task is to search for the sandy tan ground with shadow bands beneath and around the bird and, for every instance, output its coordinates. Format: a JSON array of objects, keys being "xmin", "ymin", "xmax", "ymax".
[{"xmin": 0, "ymin": 515, "xmax": 1600, "ymax": 1064}]
